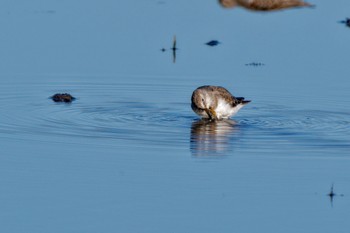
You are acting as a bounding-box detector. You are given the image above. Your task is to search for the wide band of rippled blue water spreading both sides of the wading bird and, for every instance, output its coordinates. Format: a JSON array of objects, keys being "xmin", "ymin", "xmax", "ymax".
[{"xmin": 0, "ymin": 76, "xmax": 350, "ymax": 155}]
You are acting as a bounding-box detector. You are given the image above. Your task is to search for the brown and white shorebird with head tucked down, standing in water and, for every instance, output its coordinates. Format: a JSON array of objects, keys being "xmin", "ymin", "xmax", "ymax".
[{"xmin": 191, "ymin": 85, "xmax": 251, "ymax": 121}]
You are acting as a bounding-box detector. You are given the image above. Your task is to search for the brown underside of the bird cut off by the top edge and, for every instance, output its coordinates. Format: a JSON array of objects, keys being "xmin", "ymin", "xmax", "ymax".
[{"xmin": 219, "ymin": 0, "xmax": 314, "ymax": 11}]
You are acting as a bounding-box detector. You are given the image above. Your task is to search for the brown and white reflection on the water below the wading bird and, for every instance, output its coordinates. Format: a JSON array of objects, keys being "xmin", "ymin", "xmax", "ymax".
[{"xmin": 190, "ymin": 119, "xmax": 237, "ymax": 156}]
